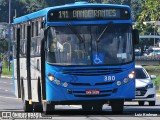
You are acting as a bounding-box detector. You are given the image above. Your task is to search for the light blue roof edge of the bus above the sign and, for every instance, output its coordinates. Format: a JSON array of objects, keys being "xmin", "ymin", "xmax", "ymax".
[{"xmin": 13, "ymin": 2, "xmax": 130, "ymax": 24}]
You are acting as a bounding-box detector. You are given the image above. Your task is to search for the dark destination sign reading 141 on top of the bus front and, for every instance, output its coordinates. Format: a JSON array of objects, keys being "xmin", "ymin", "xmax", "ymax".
[{"xmin": 48, "ymin": 8, "xmax": 130, "ymax": 21}]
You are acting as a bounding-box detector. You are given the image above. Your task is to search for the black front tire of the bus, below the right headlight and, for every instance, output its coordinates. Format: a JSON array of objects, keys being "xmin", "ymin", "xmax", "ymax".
[{"xmin": 110, "ymin": 99, "xmax": 124, "ymax": 114}]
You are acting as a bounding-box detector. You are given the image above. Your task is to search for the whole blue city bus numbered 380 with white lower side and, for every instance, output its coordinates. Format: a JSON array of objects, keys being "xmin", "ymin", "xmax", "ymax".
[{"xmin": 13, "ymin": 2, "xmax": 139, "ymax": 114}]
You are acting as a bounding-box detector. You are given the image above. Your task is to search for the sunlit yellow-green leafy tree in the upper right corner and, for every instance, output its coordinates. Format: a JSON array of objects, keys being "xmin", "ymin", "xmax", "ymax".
[{"xmin": 137, "ymin": 0, "xmax": 160, "ymax": 46}]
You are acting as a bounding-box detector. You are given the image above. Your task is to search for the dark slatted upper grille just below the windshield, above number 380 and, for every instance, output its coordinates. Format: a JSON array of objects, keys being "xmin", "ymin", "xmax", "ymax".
[{"xmin": 62, "ymin": 68, "xmax": 124, "ymax": 76}]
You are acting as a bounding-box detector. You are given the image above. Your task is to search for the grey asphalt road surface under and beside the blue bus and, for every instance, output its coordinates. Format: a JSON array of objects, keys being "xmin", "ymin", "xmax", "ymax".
[{"xmin": 0, "ymin": 78, "xmax": 160, "ymax": 120}]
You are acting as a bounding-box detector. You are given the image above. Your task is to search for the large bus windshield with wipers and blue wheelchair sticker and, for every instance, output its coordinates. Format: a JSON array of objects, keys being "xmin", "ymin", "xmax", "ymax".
[{"xmin": 46, "ymin": 24, "xmax": 133, "ymax": 65}]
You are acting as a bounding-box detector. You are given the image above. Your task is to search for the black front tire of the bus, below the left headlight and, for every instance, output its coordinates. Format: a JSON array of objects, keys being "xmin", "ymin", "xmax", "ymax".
[{"xmin": 43, "ymin": 102, "xmax": 55, "ymax": 115}]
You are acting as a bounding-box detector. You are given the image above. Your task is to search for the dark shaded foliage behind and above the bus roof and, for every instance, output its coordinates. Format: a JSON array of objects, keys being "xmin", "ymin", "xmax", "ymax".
[{"xmin": 0, "ymin": 0, "xmax": 144, "ymax": 22}]
